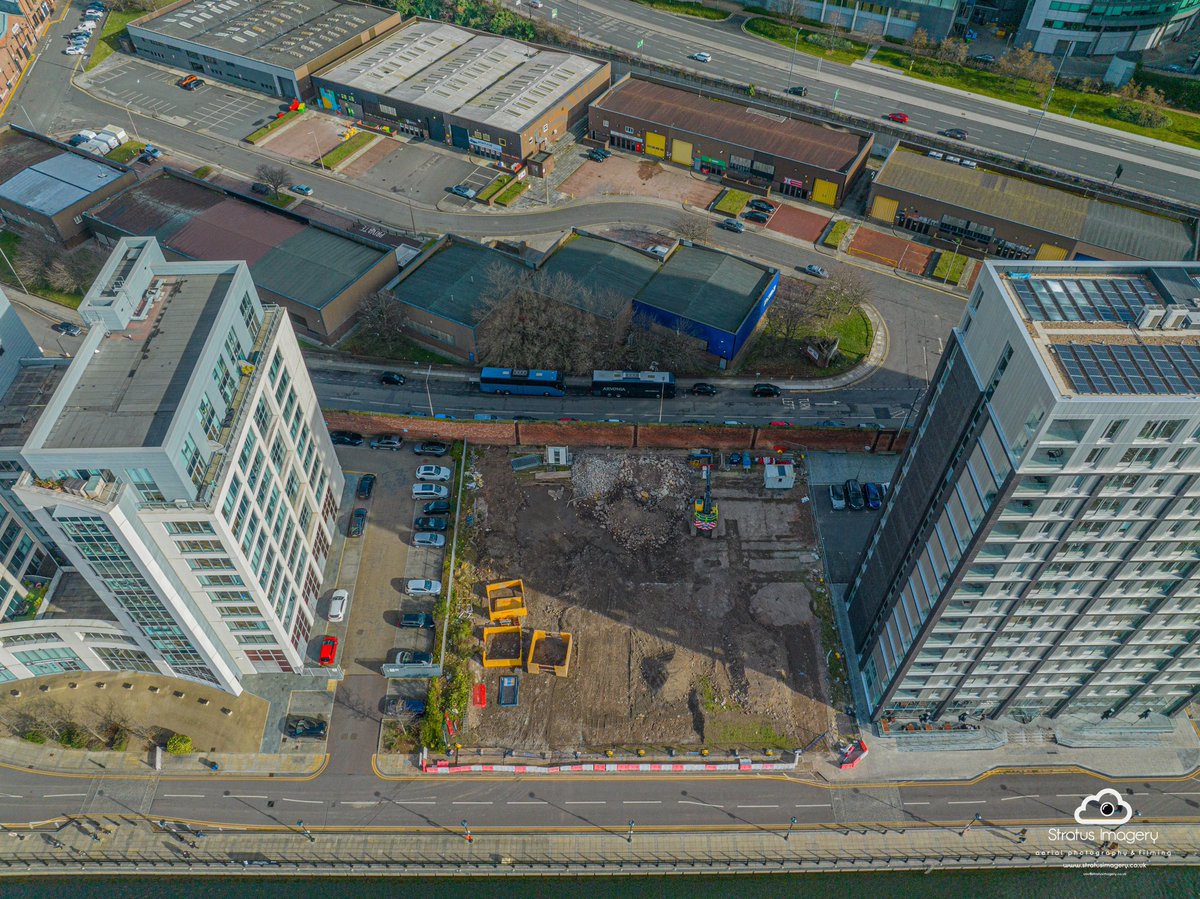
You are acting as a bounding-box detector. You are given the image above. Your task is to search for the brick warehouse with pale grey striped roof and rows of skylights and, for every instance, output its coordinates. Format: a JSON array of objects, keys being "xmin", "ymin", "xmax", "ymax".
[{"xmin": 313, "ymin": 20, "xmax": 610, "ymax": 167}]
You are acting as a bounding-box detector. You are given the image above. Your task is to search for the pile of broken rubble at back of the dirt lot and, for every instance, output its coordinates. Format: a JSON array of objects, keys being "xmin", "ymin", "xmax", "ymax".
[{"xmin": 571, "ymin": 453, "xmax": 695, "ymax": 552}]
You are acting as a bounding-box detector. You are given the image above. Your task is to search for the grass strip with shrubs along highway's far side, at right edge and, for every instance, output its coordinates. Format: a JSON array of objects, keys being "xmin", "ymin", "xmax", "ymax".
[{"xmin": 872, "ymin": 47, "xmax": 1200, "ymax": 149}]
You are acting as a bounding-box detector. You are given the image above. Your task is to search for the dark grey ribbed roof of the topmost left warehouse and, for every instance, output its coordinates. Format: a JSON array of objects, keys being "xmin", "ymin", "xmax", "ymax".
[{"xmin": 132, "ymin": 0, "xmax": 396, "ymax": 70}]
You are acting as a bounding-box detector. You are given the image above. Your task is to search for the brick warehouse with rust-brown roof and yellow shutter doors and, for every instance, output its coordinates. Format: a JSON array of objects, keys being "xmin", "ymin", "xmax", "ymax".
[{"xmin": 588, "ymin": 77, "xmax": 874, "ymax": 206}]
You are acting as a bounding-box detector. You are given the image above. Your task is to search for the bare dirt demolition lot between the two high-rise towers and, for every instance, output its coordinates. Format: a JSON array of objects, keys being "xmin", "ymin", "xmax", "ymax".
[{"xmin": 466, "ymin": 450, "xmax": 830, "ymax": 750}]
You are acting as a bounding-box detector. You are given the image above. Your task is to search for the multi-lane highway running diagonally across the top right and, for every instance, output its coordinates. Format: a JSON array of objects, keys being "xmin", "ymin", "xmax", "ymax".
[{"xmin": 505, "ymin": 0, "xmax": 1200, "ymax": 203}]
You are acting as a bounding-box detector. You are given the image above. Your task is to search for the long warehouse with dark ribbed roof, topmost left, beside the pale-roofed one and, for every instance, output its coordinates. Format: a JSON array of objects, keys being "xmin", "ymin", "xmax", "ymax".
[{"xmin": 128, "ymin": 0, "xmax": 403, "ymax": 98}]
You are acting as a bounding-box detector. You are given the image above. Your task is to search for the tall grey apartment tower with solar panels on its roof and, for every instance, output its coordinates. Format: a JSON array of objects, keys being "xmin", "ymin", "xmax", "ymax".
[{"xmin": 846, "ymin": 262, "xmax": 1200, "ymax": 721}]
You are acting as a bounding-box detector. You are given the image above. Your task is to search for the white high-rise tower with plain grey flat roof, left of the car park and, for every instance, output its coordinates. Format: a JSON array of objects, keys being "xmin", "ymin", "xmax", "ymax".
[{"xmin": 15, "ymin": 238, "xmax": 343, "ymax": 693}]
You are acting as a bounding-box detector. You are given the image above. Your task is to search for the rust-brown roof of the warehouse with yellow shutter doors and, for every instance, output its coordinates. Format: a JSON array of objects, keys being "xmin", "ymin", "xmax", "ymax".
[{"xmin": 593, "ymin": 78, "xmax": 870, "ymax": 172}]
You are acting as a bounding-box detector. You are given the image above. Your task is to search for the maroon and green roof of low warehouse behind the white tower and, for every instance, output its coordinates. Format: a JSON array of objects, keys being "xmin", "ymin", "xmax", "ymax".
[{"xmin": 89, "ymin": 173, "xmax": 388, "ymax": 310}]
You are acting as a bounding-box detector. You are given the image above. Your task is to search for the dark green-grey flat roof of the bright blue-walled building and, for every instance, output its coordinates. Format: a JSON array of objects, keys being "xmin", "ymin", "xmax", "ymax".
[{"xmin": 634, "ymin": 246, "xmax": 773, "ymax": 334}]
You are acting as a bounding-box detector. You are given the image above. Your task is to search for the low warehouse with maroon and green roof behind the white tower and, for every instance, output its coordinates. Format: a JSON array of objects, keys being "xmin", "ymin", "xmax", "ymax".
[{"xmin": 85, "ymin": 170, "xmax": 400, "ymax": 342}]
